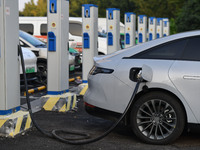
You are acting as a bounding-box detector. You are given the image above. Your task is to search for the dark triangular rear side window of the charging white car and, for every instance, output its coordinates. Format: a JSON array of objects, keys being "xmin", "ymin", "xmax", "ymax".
[{"xmin": 131, "ymin": 39, "xmax": 187, "ymax": 60}]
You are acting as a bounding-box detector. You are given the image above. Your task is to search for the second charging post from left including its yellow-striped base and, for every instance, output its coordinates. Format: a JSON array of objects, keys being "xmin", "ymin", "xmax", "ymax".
[{"xmin": 42, "ymin": 0, "xmax": 76, "ymax": 112}]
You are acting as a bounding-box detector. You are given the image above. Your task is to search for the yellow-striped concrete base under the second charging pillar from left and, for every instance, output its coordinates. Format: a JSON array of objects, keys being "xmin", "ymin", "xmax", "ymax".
[{"xmin": 40, "ymin": 93, "xmax": 76, "ymax": 112}]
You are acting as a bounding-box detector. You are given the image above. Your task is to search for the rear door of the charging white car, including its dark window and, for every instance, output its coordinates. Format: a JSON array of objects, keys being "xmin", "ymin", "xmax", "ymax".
[{"xmin": 169, "ymin": 36, "xmax": 200, "ymax": 123}]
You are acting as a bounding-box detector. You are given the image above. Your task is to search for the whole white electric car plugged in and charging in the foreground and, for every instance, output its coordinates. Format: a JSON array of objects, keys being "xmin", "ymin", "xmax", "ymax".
[{"xmin": 84, "ymin": 31, "xmax": 200, "ymax": 144}]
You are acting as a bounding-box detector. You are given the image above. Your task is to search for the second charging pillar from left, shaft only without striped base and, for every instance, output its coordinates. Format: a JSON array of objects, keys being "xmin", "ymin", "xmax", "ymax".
[{"xmin": 47, "ymin": 0, "xmax": 69, "ymax": 95}]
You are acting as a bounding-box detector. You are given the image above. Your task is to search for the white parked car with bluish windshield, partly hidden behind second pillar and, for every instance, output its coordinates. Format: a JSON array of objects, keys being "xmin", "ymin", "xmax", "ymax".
[{"xmin": 19, "ymin": 30, "xmax": 79, "ymax": 82}]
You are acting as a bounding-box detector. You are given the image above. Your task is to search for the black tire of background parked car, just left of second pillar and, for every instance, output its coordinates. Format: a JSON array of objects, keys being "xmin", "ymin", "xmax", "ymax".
[{"xmin": 37, "ymin": 61, "xmax": 47, "ymax": 85}]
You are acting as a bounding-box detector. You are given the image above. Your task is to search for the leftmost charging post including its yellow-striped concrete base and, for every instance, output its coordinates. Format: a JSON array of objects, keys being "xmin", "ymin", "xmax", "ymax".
[{"xmin": 0, "ymin": 0, "xmax": 31, "ymax": 137}]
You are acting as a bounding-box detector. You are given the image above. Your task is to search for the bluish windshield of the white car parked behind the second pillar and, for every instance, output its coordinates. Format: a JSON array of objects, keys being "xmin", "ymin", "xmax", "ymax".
[{"xmin": 19, "ymin": 31, "xmax": 46, "ymax": 48}]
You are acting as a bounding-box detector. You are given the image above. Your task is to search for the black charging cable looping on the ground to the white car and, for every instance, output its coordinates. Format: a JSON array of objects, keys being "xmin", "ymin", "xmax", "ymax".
[{"xmin": 19, "ymin": 46, "xmax": 143, "ymax": 145}]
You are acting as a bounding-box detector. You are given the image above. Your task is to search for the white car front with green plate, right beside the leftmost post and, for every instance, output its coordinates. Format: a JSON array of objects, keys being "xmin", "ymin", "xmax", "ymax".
[{"xmin": 20, "ymin": 47, "xmax": 37, "ymax": 81}]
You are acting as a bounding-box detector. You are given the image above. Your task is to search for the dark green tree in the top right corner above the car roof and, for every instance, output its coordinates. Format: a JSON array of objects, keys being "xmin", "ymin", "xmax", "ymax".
[{"xmin": 176, "ymin": 0, "xmax": 200, "ymax": 32}]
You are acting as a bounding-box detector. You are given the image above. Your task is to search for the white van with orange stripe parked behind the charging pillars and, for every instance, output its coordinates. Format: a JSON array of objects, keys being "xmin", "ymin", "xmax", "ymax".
[{"xmin": 19, "ymin": 17, "xmax": 124, "ymax": 55}]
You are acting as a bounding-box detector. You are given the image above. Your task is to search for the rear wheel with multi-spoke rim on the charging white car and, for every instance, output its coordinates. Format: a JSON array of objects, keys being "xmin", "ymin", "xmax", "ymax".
[{"xmin": 130, "ymin": 92, "xmax": 186, "ymax": 145}]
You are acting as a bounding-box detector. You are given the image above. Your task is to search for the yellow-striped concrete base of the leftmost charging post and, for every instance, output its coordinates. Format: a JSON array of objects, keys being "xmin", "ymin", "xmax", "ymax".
[{"xmin": 0, "ymin": 111, "xmax": 32, "ymax": 137}]
